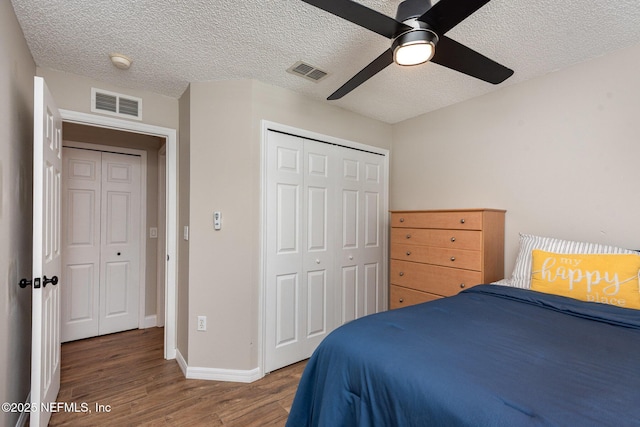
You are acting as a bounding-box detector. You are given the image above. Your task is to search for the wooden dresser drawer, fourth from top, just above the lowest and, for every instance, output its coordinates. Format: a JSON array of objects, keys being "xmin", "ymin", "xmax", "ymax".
[{"xmin": 390, "ymin": 259, "xmax": 482, "ymax": 296}]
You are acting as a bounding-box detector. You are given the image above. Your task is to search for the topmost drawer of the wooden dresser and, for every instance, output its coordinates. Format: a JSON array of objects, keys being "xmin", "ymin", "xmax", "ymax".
[{"xmin": 391, "ymin": 211, "xmax": 482, "ymax": 230}]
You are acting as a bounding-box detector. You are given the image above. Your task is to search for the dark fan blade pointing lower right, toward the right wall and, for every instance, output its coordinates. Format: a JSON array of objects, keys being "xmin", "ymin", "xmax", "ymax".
[{"xmin": 431, "ymin": 36, "xmax": 513, "ymax": 85}]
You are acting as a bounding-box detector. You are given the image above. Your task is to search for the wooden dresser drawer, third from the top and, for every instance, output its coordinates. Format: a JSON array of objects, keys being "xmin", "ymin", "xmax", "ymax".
[{"xmin": 391, "ymin": 243, "xmax": 482, "ymax": 271}]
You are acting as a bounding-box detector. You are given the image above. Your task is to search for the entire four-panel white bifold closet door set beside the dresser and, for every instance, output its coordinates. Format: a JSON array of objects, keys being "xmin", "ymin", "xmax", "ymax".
[{"xmin": 264, "ymin": 131, "xmax": 386, "ymax": 372}]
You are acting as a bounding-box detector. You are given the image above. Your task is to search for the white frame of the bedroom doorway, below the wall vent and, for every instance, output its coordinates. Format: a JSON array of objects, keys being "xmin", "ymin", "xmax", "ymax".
[{"xmin": 60, "ymin": 109, "xmax": 178, "ymax": 359}]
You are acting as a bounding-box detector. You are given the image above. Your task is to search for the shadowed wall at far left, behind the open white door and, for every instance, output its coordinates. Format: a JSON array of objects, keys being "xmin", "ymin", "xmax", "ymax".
[{"xmin": 0, "ymin": 1, "xmax": 36, "ymax": 426}]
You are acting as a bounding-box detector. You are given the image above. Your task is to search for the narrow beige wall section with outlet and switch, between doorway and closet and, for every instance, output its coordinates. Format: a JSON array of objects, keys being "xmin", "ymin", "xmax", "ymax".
[{"xmin": 188, "ymin": 80, "xmax": 256, "ymax": 370}]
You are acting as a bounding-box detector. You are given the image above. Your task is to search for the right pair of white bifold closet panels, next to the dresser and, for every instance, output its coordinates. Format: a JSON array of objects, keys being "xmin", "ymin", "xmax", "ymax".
[{"xmin": 335, "ymin": 147, "xmax": 386, "ymax": 324}]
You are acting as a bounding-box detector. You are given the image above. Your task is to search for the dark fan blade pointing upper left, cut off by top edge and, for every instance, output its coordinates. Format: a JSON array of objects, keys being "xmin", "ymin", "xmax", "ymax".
[{"xmin": 302, "ymin": 0, "xmax": 411, "ymax": 39}]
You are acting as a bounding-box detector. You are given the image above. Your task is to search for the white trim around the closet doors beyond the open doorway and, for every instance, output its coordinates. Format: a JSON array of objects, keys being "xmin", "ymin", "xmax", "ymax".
[{"xmin": 62, "ymin": 142, "xmax": 148, "ymax": 329}]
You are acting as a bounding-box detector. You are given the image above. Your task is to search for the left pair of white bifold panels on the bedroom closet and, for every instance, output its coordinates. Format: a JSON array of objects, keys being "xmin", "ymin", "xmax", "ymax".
[{"xmin": 265, "ymin": 132, "xmax": 336, "ymax": 372}]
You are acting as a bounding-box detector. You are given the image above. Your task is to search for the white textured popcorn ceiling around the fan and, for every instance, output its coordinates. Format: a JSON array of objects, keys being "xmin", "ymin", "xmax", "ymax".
[{"xmin": 12, "ymin": 0, "xmax": 640, "ymax": 123}]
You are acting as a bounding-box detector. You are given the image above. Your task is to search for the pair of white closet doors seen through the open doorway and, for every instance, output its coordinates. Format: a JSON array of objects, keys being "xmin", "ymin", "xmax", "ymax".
[{"xmin": 62, "ymin": 148, "xmax": 141, "ymax": 342}]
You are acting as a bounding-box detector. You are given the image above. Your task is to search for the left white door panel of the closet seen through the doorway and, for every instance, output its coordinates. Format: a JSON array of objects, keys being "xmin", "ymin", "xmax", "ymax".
[{"xmin": 61, "ymin": 148, "xmax": 102, "ymax": 342}]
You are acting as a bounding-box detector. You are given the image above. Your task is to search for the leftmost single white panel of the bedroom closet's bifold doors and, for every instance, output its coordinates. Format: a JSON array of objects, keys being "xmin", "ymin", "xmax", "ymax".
[{"xmin": 265, "ymin": 132, "xmax": 305, "ymax": 372}]
